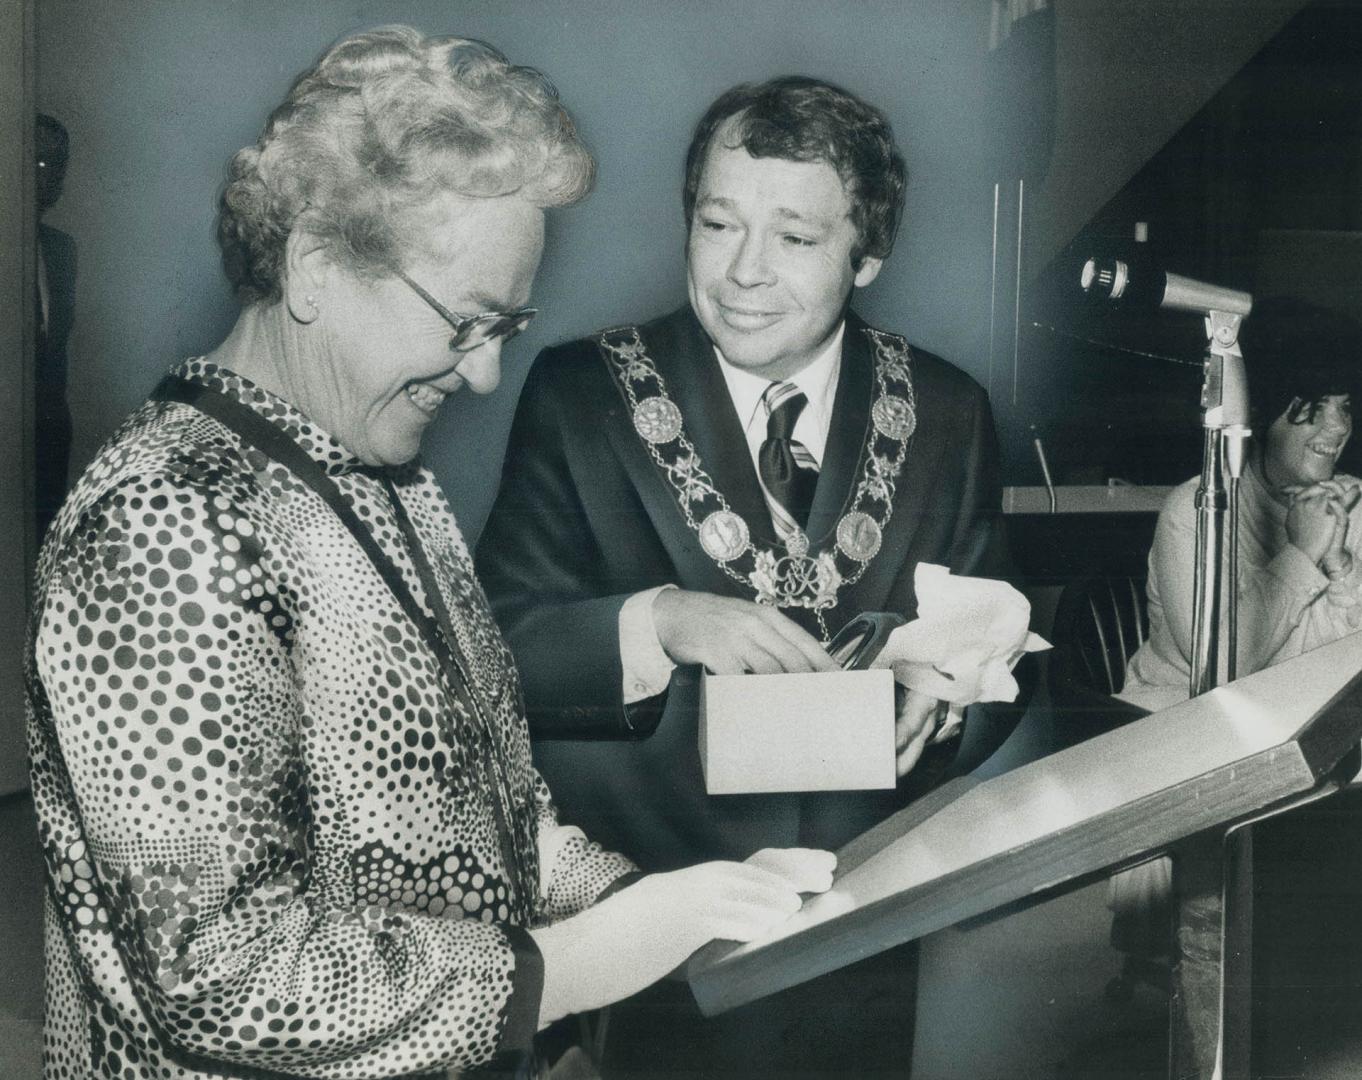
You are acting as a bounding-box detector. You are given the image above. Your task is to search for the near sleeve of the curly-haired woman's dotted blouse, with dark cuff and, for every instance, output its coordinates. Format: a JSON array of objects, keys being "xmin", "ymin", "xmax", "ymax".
[{"xmin": 33, "ymin": 478, "xmax": 544, "ymax": 1077}]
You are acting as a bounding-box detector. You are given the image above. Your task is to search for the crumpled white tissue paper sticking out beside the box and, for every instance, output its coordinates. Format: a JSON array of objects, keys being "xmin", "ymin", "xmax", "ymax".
[{"xmin": 870, "ymin": 562, "xmax": 1050, "ymax": 742}]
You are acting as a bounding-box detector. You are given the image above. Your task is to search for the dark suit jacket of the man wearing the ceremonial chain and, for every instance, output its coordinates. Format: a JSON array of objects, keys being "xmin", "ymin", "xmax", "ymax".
[{"xmin": 477, "ymin": 306, "xmax": 1016, "ymax": 870}]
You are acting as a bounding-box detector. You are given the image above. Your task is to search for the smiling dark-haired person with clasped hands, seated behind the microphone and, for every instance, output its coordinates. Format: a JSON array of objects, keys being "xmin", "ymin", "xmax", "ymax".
[{"xmin": 1121, "ymin": 300, "xmax": 1362, "ymax": 708}]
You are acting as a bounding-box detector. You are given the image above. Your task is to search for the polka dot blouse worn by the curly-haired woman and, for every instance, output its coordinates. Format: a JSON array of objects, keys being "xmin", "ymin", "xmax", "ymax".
[{"xmin": 27, "ymin": 361, "xmax": 633, "ymax": 1080}]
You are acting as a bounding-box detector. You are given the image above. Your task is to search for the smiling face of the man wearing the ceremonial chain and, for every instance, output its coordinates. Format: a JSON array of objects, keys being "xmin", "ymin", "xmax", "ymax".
[{"xmin": 686, "ymin": 125, "xmax": 881, "ymax": 380}]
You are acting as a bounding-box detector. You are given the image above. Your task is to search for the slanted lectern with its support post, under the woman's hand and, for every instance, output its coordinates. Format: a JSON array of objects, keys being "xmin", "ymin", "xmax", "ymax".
[{"xmin": 688, "ymin": 633, "xmax": 1362, "ymax": 1080}]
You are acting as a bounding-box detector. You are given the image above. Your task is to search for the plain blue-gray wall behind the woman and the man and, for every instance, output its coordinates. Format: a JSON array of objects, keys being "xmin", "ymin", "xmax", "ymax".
[{"xmin": 38, "ymin": 0, "xmax": 992, "ymax": 534}]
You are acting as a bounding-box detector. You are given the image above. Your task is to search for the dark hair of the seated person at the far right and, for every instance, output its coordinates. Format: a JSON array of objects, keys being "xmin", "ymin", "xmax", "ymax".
[{"xmin": 1239, "ymin": 297, "xmax": 1362, "ymax": 436}]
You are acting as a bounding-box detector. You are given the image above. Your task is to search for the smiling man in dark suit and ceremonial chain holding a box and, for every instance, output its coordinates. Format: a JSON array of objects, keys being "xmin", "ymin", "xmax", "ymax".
[{"xmin": 478, "ymin": 76, "xmax": 1011, "ymax": 1075}]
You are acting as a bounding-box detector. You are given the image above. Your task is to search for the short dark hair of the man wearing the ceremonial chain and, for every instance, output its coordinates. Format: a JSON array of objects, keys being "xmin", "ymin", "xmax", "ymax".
[{"xmin": 682, "ymin": 75, "xmax": 907, "ymax": 268}]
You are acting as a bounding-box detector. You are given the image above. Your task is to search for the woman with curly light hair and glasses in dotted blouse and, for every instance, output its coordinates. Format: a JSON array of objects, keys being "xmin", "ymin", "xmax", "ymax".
[{"xmin": 29, "ymin": 27, "xmax": 831, "ymax": 1079}]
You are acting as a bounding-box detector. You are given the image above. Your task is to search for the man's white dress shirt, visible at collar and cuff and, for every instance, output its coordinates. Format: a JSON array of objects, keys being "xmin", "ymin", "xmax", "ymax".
[{"xmin": 620, "ymin": 323, "xmax": 846, "ymax": 705}]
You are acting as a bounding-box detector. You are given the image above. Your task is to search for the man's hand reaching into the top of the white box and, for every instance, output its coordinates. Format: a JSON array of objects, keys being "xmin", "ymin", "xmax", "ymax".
[{"xmin": 652, "ymin": 588, "xmax": 838, "ymax": 676}]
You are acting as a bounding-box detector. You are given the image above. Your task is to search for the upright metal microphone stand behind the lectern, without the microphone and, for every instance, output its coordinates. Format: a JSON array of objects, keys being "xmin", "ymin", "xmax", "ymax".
[{"xmin": 1189, "ymin": 309, "xmax": 1249, "ymax": 697}]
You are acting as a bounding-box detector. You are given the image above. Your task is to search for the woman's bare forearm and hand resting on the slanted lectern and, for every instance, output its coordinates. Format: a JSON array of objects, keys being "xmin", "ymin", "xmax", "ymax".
[{"xmin": 531, "ymin": 848, "xmax": 836, "ymax": 1027}]
